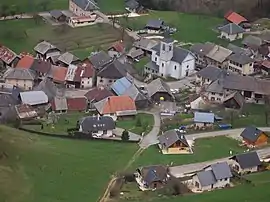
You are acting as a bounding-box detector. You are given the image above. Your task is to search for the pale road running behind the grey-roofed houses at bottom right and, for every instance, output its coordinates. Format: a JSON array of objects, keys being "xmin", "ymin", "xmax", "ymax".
[{"xmin": 170, "ymin": 148, "xmax": 270, "ymax": 177}]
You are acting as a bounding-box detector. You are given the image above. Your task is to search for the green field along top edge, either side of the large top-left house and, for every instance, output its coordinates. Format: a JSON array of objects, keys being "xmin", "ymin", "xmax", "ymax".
[{"xmin": 0, "ymin": 0, "xmax": 125, "ymax": 13}]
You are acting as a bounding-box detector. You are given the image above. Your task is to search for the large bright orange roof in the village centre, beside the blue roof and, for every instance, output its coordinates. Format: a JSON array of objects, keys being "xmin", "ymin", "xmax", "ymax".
[{"xmin": 99, "ymin": 95, "xmax": 136, "ymax": 114}]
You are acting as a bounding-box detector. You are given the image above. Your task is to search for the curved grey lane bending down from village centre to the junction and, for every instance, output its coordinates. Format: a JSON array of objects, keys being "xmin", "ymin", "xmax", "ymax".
[{"xmin": 139, "ymin": 110, "xmax": 160, "ymax": 148}]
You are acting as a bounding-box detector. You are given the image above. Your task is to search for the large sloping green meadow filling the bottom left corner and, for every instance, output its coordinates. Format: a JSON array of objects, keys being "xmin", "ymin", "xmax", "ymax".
[{"xmin": 0, "ymin": 126, "xmax": 137, "ymax": 202}]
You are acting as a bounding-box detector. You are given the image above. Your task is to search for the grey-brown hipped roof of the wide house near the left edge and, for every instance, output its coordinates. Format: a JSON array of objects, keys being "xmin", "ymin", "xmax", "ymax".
[{"xmin": 3, "ymin": 68, "xmax": 37, "ymax": 80}]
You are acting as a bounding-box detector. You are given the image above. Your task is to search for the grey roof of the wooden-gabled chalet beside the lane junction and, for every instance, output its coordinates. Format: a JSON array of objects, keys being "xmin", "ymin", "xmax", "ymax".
[{"xmin": 158, "ymin": 130, "xmax": 189, "ymax": 149}]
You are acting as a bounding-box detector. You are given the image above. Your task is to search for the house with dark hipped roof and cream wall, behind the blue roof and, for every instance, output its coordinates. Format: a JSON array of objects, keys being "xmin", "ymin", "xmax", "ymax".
[{"xmin": 97, "ymin": 60, "xmax": 127, "ymax": 86}]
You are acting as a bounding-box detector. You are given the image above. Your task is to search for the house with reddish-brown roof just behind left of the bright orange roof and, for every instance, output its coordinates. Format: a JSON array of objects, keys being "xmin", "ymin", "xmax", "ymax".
[{"xmin": 84, "ymin": 87, "xmax": 114, "ymax": 110}]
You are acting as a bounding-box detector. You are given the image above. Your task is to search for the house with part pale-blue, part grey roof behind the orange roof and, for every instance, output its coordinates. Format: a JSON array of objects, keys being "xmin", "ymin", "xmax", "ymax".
[{"xmin": 111, "ymin": 77, "xmax": 150, "ymax": 109}]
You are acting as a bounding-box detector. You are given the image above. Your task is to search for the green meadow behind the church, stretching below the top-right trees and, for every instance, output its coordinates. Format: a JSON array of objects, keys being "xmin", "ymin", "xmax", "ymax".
[{"xmin": 120, "ymin": 11, "xmax": 223, "ymax": 43}]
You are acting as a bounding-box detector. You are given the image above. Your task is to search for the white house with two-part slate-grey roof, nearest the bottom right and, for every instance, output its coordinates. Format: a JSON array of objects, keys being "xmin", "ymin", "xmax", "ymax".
[{"xmin": 192, "ymin": 162, "xmax": 233, "ymax": 191}]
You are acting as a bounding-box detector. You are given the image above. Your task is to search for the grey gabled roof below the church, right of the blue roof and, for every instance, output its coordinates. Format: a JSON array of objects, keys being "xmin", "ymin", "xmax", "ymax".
[{"xmin": 147, "ymin": 78, "xmax": 174, "ymax": 97}]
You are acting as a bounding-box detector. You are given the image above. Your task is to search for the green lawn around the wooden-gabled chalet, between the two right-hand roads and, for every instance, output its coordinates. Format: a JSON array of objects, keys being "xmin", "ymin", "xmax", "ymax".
[{"xmin": 133, "ymin": 136, "xmax": 244, "ymax": 167}]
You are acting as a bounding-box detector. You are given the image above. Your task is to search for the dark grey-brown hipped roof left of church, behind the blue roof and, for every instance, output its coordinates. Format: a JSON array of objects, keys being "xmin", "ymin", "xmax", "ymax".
[{"xmin": 97, "ymin": 60, "xmax": 127, "ymax": 79}]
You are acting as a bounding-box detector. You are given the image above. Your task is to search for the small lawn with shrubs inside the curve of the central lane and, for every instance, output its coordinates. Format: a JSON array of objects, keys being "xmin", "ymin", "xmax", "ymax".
[{"xmin": 116, "ymin": 113, "xmax": 154, "ymax": 134}]
